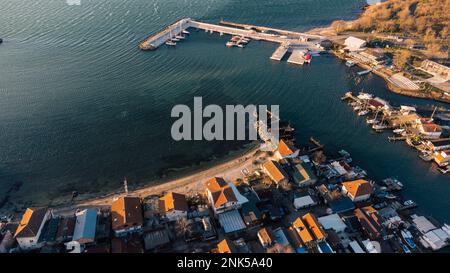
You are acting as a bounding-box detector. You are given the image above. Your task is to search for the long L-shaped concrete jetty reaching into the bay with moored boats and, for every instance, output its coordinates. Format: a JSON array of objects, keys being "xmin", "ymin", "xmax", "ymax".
[{"xmin": 139, "ymin": 18, "xmax": 325, "ymax": 64}]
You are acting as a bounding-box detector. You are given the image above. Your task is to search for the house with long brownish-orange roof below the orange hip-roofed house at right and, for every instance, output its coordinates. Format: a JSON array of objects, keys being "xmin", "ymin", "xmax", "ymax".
[{"xmin": 354, "ymin": 206, "xmax": 382, "ymax": 240}]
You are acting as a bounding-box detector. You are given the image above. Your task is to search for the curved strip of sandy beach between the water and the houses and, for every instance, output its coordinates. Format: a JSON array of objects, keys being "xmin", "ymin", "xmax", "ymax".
[{"xmin": 49, "ymin": 144, "xmax": 264, "ymax": 213}]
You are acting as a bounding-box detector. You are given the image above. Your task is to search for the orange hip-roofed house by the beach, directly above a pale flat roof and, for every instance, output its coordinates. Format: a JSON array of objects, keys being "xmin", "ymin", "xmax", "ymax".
[{"xmin": 205, "ymin": 177, "xmax": 248, "ymax": 215}]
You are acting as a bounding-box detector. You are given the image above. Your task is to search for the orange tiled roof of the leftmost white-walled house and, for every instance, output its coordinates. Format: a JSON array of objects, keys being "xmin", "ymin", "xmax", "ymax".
[{"xmin": 14, "ymin": 208, "xmax": 47, "ymax": 238}]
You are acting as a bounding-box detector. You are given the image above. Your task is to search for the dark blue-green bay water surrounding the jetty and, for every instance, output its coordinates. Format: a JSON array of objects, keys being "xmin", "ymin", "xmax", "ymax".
[{"xmin": 0, "ymin": 0, "xmax": 450, "ymax": 221}]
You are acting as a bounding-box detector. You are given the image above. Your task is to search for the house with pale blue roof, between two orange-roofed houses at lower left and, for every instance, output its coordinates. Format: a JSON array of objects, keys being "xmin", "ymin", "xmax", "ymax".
[{"xmin": 72, "ymin": 208, "xmax": 97, "ymax": 244}]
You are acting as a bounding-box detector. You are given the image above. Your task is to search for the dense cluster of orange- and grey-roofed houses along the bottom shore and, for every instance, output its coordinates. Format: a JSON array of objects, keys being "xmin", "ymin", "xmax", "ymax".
[{"xmin": 0, "ymin": 137, "xmax": 450, "ymax": 253}]
